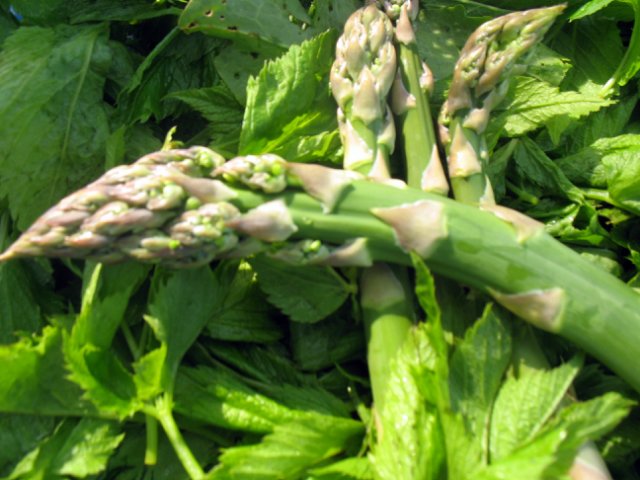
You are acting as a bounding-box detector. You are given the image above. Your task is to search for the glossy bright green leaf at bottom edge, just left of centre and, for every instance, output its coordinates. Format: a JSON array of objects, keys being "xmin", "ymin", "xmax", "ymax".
[{"xmin": 210, "ymin": 414, "xmax": 364, "ymax": 480}]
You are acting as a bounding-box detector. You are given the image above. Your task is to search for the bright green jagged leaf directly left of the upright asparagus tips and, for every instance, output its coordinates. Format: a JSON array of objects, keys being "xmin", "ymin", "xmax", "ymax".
[{"xmin": 240, "ymin": 32, "xmax": 340, "ymax": 162}]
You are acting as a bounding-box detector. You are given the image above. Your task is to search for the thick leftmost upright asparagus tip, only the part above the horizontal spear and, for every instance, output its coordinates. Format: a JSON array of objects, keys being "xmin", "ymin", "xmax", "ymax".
[{"xmin": 330, "ymin": 5, "xmax": 396, "ymax": 178}]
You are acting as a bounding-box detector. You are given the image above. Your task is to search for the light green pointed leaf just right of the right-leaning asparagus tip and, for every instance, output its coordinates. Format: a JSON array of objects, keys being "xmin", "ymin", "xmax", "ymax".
[{"xmin": 489, "ymin": 77, "xmax": 612, "ymax": 136}]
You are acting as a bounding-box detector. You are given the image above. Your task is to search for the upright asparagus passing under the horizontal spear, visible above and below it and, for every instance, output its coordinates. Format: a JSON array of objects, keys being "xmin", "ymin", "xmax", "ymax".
[{"xmin": 331, "ymin": 5, "xmax": 413, "ymax": 412}]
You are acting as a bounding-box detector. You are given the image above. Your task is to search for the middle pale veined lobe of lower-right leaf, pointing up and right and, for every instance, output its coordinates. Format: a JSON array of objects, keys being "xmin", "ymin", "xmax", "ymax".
[{"xmin": 489, "ymin": 357, "xmax": 582, "ymax": 461}]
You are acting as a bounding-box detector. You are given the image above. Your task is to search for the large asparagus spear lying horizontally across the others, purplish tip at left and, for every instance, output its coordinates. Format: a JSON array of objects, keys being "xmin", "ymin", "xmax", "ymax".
[{"xmin": 0, "ymin": 147, "xmax": 640, "ymax": 398}]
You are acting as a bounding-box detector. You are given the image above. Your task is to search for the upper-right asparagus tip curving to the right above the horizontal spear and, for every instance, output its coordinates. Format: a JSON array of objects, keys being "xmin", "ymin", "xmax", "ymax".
[{"xmin": 439, "ymin": 6, "xmax": 564, "ymax": 204}]
